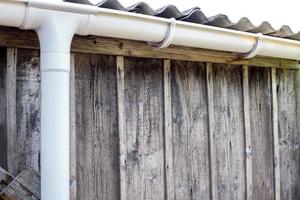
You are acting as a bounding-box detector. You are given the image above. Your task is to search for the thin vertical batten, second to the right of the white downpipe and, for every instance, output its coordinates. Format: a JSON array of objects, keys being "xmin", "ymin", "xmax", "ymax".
[{"xmin": 117, "ymin": 56, "xmax": 127, "ymax": 200}]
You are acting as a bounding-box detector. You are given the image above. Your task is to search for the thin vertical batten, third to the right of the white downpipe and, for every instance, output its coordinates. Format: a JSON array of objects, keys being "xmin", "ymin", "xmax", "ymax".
[{"xmin": 164, "ymin": 60, "xmax": 175, "ymax": 200}]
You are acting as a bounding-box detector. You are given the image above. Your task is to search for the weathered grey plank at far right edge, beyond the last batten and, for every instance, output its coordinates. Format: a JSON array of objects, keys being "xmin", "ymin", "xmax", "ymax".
[{"xmin": 276, "ymin": 70, "xmax": 300, "ymax": 200}]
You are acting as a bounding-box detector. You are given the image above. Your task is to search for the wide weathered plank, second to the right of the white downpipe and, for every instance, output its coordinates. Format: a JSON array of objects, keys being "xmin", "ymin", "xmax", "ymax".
[{"xmin": 125, "ymin": 58, "xmax": 165, "ymax": 200}]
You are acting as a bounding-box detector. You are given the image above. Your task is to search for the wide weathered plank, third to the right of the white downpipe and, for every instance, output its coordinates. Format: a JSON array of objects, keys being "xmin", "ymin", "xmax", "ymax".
[{"xmin": 170, "ymin": 61, "xmax": 210, "ymax": 200}]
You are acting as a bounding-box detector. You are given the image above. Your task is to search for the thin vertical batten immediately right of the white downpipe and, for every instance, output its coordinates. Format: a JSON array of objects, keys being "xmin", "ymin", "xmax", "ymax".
[{"xmin": 70, "ymin": 53, "xmax": 76, "ymax": 200}]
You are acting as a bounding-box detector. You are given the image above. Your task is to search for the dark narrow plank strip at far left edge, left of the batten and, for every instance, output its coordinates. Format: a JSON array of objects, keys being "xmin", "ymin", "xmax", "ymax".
[{"xmin": 0, "ymin": 47, "xmax": 7, "ymax": 168}]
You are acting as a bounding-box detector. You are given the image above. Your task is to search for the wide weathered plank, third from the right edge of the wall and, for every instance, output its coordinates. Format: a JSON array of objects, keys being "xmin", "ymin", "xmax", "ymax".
[{"xmin": 213, "ymin": 64, "xmax": 246, "ymax": 200}]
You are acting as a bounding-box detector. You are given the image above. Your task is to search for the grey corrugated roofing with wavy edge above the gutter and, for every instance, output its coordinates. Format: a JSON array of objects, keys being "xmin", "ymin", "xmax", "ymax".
[{"xmin": 65, "ymin": 0, "xmax": 300, "ymax": 41}]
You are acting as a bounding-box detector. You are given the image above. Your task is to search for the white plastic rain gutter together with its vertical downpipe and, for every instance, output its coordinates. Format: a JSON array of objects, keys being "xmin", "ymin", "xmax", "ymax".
[{"xmin": 0, "ymin": 0, "xmax": 300, "ymax": 200}]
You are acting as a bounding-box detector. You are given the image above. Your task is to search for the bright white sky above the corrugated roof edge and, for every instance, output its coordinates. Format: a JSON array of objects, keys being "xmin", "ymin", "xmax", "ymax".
[{"xmin": 90, "ymin": 0, "xmax": 300, "ymax": 32}]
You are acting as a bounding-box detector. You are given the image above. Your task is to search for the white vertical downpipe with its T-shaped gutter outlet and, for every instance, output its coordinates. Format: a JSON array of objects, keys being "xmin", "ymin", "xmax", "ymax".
[{"xmin": 22, "ymin": 4, "xmax": 89, "ymax": 200}]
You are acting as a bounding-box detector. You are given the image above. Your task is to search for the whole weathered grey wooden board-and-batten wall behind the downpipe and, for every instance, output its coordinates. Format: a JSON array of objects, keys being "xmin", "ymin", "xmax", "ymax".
[{"xmin": 0, "ymin": 48, "xmax": 300, "ymax": 200}]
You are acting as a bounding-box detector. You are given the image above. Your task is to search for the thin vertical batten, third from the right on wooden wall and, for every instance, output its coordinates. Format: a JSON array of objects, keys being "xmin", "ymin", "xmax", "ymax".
[{"xmin": 206, "ymin": 63, "xmax": 218, "ymax": 200}]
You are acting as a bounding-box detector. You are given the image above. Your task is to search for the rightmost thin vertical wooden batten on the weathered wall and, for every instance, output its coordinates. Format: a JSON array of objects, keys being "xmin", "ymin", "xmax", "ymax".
[{"xmin": 271, "ymin": 68, "xmax": 280, "ymax": 200}]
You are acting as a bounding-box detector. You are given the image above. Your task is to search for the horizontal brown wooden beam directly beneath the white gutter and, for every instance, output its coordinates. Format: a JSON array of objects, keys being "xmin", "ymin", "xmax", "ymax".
[{"xmin": 0, "ymin": 27, "xmax": 300, "ymax": 69}]
